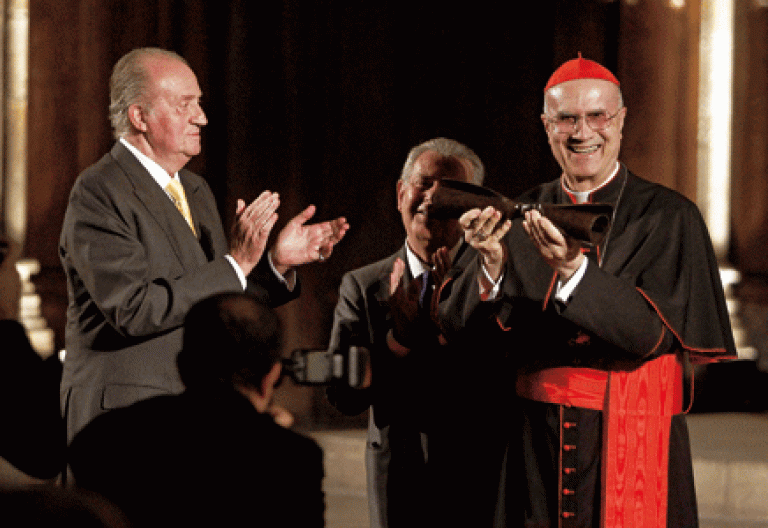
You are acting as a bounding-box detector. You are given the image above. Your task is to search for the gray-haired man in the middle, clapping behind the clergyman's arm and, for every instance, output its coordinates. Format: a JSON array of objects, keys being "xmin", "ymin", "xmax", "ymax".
[{"xmin": 328, "ymin": 138, "xmax": 508, "ymax": 528}]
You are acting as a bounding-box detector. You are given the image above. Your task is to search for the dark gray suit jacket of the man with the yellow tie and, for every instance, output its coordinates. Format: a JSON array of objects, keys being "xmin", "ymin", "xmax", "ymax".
[{"xmin": 59, "ymin": 142, "xmax": 298, "ymax": 441}]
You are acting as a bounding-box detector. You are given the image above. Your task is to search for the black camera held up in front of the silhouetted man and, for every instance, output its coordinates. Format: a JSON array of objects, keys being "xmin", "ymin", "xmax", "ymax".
[{"xmin": 283, "ymin": 346, "xmax": 370, "ymax": 389}]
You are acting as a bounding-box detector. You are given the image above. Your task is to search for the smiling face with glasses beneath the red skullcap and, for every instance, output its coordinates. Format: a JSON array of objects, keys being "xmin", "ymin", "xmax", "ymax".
[{"xmin": 542, "ymin": 79, "xmax": 627, "ymax": 191}]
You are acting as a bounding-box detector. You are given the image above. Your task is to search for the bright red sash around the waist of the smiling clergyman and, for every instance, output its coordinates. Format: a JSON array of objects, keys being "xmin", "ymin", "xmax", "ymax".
[{"xmin": 517, "ymin": 354, "xmax": 683, "ymax": 528}]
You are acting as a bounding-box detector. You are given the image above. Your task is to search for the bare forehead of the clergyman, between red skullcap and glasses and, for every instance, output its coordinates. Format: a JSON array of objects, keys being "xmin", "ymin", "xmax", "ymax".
[{"xmin": 545, "ymin": 79, "xmax": 621, "ymax": 114}]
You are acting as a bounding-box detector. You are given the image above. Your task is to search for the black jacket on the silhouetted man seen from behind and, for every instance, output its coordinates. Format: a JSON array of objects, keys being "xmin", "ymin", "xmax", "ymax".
[{"xmin": 68, "ymin": 388, "xmax": 325, "ymax": 528}]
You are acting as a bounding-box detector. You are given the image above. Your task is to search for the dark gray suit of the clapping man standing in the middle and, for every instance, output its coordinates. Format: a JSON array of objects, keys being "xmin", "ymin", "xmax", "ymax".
[{"xmin": 328, "ymin": 243, "xmax": 502, "ymax": 528}]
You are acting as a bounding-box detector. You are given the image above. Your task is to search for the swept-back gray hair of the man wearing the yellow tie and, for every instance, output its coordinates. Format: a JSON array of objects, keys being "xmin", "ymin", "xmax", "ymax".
[{"xmin": 109, "ymin": 48, "xmax": 189, "ymax": 139}]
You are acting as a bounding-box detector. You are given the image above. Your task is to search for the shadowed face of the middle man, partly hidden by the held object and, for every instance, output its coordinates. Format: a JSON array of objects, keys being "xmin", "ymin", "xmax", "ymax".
[{"xmin": 397, "ymin": 150, "xmax": 472, "ymax": 262}]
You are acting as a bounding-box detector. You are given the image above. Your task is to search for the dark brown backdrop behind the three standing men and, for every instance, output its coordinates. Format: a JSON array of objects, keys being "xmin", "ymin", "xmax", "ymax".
[{"xmin": 25, "ymin": 0, "xmax": 768, "ymax": 423}]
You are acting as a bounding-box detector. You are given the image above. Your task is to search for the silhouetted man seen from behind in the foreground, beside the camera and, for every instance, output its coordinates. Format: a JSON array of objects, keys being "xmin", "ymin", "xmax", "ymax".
[{"xmin": 69, "ymin": 293, "xmax": 325, "ymax": 527}]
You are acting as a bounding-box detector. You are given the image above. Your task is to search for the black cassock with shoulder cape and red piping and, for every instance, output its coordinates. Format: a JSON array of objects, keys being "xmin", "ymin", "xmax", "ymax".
[{"xmin": 440, "ymin": 165, "xmax": 736, "ymax": 528}]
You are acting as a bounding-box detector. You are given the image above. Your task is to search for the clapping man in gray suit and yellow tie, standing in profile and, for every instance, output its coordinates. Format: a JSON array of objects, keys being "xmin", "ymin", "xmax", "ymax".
[{"xmin": 59, "ymin": 48, "xmax": 348, "ymax": 454}]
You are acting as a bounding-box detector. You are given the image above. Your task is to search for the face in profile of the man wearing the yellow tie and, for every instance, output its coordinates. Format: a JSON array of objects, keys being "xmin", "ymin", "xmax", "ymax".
[{"xmin": 130, "ymin": 56, "xmax": 208, "ymax": 174}]
